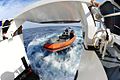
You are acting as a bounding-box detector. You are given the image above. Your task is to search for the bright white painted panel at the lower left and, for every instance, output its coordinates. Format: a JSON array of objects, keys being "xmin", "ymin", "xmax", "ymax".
[{"xmin": 0, "ymin": 34, "xmax": 28, "ymax": 80}]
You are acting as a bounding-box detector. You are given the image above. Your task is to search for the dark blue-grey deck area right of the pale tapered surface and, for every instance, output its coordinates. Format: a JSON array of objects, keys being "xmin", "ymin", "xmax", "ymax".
[{"xmin": 96, "ymin": 45, "xmax": 120, "ymax": 80}]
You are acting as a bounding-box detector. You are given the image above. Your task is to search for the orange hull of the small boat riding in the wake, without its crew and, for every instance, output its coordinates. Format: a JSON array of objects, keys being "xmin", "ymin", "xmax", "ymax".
[{"xmin": 44, "ymin": 35, "xmax": 76, "ymax": 52}]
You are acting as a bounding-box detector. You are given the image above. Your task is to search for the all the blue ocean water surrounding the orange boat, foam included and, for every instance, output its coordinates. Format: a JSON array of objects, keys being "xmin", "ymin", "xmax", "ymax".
[{"xmin": 23, "ymin": 26, "xmax": 83, "ymax": 80}]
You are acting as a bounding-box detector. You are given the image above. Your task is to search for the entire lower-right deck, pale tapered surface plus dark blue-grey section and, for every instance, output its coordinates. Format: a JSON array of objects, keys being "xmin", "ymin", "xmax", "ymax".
[{"xmin": 75, "ymin": 42, "xmax": 120, "ymax": 80}]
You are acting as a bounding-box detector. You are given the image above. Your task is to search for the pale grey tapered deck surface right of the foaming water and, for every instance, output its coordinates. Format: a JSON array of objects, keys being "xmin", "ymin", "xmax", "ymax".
[{"xmin": 77, "ymin": 50, "xmax": 108, "ymax": 80}]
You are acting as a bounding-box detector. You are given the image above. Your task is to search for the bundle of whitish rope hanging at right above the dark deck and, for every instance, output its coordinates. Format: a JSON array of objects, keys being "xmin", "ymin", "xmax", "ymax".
[{"xmin": 92, "ymin": 30, "xmax": 109, "ymax": 59}]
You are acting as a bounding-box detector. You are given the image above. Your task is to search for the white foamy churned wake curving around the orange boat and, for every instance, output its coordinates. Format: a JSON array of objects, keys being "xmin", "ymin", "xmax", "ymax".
[{"xmin": 27, "ymin": 28, "xmax": 82, "ymax": 80}]
